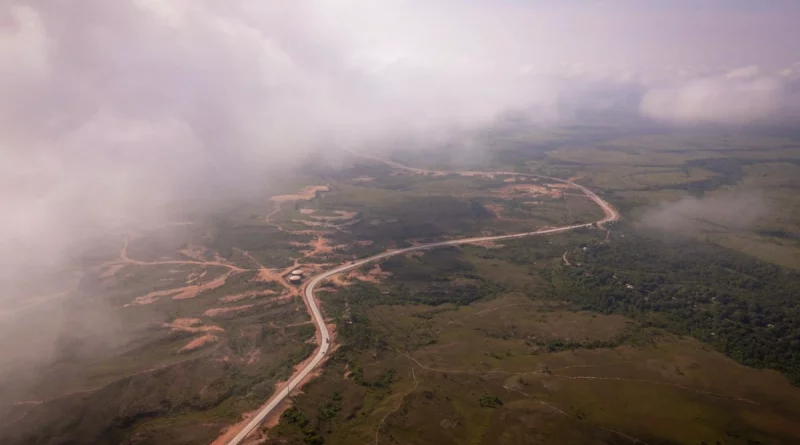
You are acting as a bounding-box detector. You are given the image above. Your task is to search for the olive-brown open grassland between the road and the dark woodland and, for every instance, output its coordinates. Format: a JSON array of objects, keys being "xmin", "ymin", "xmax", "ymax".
[{"xmin": 267, "ymin": 246, "xmax": 800, "ymax": 444}]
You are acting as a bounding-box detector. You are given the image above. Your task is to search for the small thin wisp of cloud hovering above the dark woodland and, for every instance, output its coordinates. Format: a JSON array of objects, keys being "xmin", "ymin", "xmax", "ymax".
[{"xmin": 640, "ymin": 192, "xmax": 769, "ymax": 232}]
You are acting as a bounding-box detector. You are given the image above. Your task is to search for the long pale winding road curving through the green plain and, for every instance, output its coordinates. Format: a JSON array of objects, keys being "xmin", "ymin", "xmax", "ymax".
[{"xmin": 228, "ymin": 158, "xmax": 619, "ymax": 445}]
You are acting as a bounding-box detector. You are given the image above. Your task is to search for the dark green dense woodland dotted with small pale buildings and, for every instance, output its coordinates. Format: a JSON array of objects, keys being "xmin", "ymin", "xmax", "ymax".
[{"xmin": 543, "ymin": 232, "xmax": 800, "ymax": 384}]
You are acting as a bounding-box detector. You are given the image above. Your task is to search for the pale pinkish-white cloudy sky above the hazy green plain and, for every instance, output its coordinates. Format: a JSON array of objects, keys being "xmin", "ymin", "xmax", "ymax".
[{"xmin": 0, "ymin": 0, "xmax": 800, "ymax": 276}]
